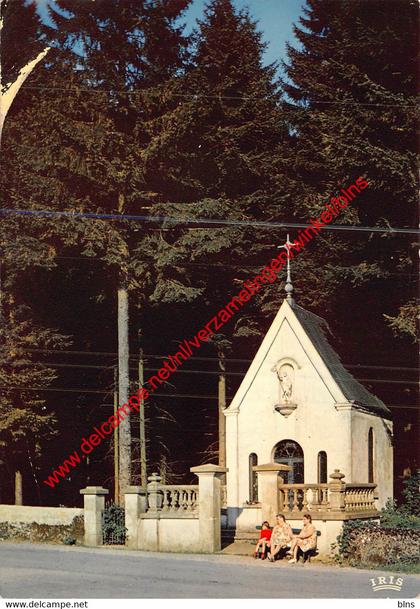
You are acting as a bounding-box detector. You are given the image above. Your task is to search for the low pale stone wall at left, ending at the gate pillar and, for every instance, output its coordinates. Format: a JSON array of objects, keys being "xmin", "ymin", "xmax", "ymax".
[{"xmin": 0, "ymin": 505, "xmax": 84, "ymax": 544}]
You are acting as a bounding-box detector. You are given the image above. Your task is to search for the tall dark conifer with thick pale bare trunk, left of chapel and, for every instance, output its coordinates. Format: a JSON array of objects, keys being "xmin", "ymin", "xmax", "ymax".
[{"xmin": 0, "ymin": 0, "xmax": 188, "ymax": 496}]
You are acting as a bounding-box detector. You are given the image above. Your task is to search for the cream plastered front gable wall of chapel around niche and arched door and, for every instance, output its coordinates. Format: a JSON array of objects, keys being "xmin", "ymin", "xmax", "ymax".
[{"xmin": 235, "ymin": 354, "xmax": 351, "ymax": 504}]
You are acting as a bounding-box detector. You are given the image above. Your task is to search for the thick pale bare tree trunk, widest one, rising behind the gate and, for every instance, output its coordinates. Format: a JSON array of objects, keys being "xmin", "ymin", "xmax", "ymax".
[{"xmin": 118, "ymin": 287, "xmax": 131, "ymax": 501}]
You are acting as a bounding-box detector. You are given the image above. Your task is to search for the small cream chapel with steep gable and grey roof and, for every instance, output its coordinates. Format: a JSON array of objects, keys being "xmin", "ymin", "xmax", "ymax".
[{"xmin": 224, "ymin": 270, "xmax": 393, "ymax": 531}]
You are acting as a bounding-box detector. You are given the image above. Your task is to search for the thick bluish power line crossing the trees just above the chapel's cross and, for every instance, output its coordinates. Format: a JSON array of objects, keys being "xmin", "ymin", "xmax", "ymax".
[{"xmin": 0, "ymin": 208, "xmax": 420, "ymax": 235}]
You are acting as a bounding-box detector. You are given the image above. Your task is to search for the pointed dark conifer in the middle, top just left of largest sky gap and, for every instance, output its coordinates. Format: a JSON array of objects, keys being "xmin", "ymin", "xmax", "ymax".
[{"xmin": 139, "ymin": 0, "xmax": 296, "ymax": 332}]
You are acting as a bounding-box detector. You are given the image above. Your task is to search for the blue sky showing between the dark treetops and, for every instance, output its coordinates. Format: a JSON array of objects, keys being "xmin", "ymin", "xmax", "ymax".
[{"xmin": 36, "ymin": 0, "xmax": 305, "ymax": 63}]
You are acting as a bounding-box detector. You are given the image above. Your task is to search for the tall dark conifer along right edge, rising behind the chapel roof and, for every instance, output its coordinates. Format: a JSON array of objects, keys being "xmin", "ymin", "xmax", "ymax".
[{"xmin": 283, "ymin": 0, "xmax": 419, "ymax": 484}]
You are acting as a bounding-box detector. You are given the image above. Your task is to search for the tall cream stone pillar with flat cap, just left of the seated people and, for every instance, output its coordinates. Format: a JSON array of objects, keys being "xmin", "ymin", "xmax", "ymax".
[{"xmin": 190, "ymin": 463, "xmax": 228, "ymax": 553}]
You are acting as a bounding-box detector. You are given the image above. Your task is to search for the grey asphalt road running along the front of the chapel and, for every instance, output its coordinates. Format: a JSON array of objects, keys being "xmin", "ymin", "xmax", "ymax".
[{"xmin": 0, "ymin": 542, "xmax": 420, "ymax": 599}]
